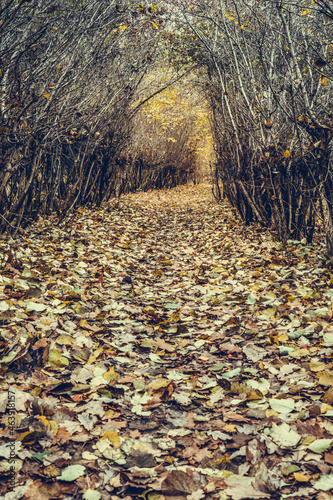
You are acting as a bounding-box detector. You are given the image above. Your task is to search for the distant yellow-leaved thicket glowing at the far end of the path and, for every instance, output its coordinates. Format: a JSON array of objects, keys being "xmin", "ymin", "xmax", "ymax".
[{"xmin": 118, "ymin": 82, "xmax": 204, "ymax": 190}]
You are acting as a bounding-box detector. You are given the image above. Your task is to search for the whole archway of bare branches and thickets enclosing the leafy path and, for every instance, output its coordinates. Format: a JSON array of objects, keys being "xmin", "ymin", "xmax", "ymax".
[{"xmin": 0, "ymin": 0, "xmax": 333, "ymax": 253}]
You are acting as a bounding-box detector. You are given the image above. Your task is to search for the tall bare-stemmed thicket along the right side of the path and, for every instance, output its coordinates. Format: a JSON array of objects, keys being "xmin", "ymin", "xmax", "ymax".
[{"xmin": 178, "ymin": 0, "xmax": 333, "ymax": 253}]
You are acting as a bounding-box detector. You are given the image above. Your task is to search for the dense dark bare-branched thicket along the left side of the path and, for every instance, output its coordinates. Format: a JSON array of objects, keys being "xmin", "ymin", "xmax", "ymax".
[{"xmin": 0, "ymin": 0, "xmax": 196, "ymax": 231}]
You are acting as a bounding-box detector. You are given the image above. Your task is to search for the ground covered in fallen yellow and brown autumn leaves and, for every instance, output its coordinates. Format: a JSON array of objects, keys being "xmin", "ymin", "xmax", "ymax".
[{"xmin": 0, "ymin": 185, "xmax": 333, "ymax": 500}]
